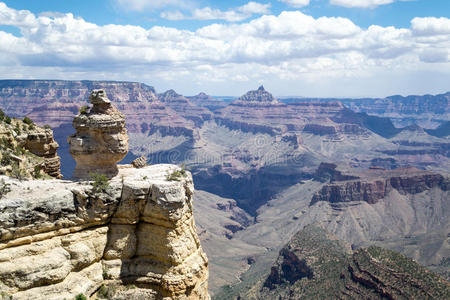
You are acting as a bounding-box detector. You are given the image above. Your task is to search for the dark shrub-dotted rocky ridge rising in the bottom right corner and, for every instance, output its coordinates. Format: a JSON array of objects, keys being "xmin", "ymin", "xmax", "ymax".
[{"xmin": 248, "ymin": 225, "xmax": 450, "ymax": 300}]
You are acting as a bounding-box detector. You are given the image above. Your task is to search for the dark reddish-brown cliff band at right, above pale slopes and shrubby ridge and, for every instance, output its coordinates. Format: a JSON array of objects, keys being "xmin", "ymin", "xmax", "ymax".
[{"xmin": 310, "ymin": 168, "xmax": 450, "ymax": 205}]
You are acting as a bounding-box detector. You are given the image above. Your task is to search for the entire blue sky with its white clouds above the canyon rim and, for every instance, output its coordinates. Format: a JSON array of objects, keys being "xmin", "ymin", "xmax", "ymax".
[{"xmin": 0, "ymin": 0, "xmax": 450, "ymax": 97}]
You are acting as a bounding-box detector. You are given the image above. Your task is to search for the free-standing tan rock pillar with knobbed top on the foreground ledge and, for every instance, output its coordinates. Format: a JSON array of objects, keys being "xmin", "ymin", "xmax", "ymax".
[{"xmin": 68, "ymin": 90, "xmax": 128, "ymax": 179}]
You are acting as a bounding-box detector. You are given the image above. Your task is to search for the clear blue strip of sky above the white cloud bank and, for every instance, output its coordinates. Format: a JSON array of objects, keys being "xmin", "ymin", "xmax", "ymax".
[{"xmin": 3, "ymin": 0, "xmax": 450, "ymax": 30}]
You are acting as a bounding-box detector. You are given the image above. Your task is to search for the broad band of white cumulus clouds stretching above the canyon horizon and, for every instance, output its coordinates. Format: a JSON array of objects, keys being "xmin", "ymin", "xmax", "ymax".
[{"xmin": 0, "ymin": 2, "xmax": 450, "ymax": 92}]
